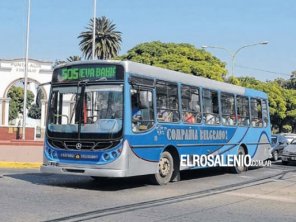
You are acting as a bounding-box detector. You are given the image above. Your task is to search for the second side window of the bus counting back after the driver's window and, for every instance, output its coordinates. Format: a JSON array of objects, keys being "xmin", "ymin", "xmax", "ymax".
[{"xmin": 182, "ymin": 86, "xmax": 201, "ymax": 123}]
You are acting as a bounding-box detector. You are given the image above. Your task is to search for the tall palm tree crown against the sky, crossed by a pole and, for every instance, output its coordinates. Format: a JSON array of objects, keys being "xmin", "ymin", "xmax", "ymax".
[{"xmin": 78, "ymin": 16, "xmax": 121, "ymax": 59}]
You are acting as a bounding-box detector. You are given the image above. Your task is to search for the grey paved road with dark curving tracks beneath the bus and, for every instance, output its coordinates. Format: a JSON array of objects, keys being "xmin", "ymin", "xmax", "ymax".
[{"xmin": 0, "ymin": 164, "xmax": 296, "ymax": 222}]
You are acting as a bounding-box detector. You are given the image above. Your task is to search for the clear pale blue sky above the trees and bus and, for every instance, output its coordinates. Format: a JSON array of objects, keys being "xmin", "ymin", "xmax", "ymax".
[{"xmin": 0, "ymin": 0, "xmax": 296, "ymax": 80}]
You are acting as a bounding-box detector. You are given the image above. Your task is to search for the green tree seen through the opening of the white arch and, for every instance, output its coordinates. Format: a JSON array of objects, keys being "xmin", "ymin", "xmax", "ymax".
[{"xmin": 8, "ymin": 86, "xmax": 34, "ymax": 120}]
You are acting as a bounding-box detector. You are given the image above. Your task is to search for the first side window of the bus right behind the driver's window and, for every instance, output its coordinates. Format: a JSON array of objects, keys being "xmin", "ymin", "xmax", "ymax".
[{"xmin": 156, "ymin": 82, "xmax": 180, "ymax": 122}]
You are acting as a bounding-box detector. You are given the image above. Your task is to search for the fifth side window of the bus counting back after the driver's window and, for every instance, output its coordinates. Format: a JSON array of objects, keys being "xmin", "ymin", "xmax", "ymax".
[{"xmin": 236, "ymin": 96, "xmax": 250, "ymax": 126}]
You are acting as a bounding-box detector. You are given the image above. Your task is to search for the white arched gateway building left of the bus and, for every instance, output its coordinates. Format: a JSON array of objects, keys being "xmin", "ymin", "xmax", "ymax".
[{"xmin": 0, "ymin": 59, "xmax": 53, "ymax": 134}]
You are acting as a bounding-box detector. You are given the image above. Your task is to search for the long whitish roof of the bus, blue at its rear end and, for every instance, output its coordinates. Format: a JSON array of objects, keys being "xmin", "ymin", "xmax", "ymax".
[{"xmin": 56, "ymin": 60, "xmax": 267, "ymax": 99}]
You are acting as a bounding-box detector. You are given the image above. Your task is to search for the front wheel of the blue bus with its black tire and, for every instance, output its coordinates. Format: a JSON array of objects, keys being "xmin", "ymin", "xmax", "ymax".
[{"xmin": 151, "ymin": 151, "xmax": 174, "ymax": 185}]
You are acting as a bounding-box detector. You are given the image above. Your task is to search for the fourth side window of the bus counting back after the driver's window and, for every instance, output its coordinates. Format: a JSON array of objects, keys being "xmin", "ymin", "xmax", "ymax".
[{"xmin": 221, "ymin": 93, "xmax": 236, "ymax": 126}]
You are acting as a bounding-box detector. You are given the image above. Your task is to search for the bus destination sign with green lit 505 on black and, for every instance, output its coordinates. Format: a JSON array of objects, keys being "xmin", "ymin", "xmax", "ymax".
[{"xmin": 52, "ymin": 64, "xmax": 124, "ymax": 83}]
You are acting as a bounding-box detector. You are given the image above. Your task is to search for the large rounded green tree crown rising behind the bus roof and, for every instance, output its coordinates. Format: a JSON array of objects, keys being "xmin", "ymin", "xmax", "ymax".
[{"xmin": 119, "ymin": 41, "xmax": 227, "ymax": 81}]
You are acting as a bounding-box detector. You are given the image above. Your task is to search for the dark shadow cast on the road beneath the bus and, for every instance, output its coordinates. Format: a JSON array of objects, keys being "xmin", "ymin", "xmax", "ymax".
[{"xmin": 3, "ymin": 163, "xmax": 288, "ymax": 191}]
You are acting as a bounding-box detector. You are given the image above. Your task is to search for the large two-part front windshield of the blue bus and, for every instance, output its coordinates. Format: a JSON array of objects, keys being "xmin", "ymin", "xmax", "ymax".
[{"xmin": 48, "ymin": 85, "xmax": 123, "ymax": 139}]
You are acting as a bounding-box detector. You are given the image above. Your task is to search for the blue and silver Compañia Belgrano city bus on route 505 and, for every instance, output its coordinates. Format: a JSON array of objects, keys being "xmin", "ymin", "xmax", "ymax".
[{"xmin": 41, "ymin": 61, "xmax": 271, "ymax": 184}]
